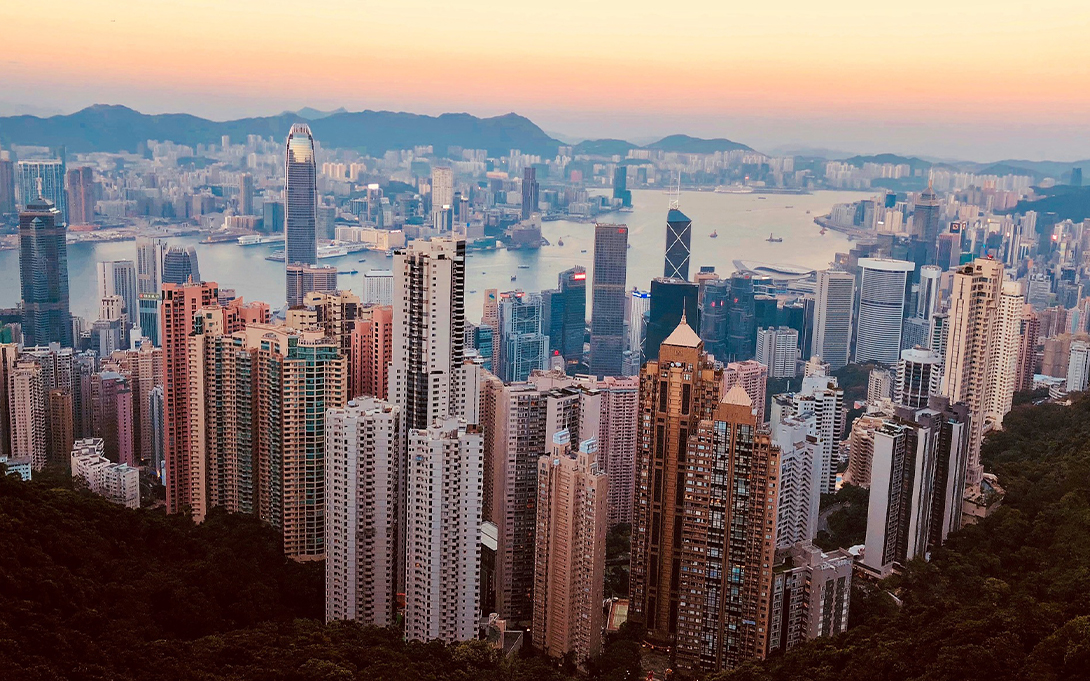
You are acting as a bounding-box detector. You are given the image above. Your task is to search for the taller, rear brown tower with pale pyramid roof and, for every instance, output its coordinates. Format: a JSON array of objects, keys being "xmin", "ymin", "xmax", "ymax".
[{"xmin": 629, "ymin": 313, "xmax": 723, "ymax": 644}]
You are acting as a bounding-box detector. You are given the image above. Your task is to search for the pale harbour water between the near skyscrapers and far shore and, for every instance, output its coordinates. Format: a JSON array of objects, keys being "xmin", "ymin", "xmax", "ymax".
[{"xmin": 0, "ymin": 190, "xmax": 860, "ymax": 321}]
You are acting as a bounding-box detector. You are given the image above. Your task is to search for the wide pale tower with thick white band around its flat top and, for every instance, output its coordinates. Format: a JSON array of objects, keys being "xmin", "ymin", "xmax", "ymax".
[{"xmin": 856, "ymin": 258, "xmax": 916, "ymax": 365}]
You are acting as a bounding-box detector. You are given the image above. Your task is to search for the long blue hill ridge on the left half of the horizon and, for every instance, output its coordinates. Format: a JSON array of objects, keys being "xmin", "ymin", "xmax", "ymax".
[{"xmin": 0, "ymin": 105, "xmax": 559, "ymax": 156}]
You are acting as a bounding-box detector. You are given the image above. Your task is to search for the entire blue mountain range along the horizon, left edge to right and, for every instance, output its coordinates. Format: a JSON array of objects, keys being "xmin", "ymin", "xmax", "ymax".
[{"xmin": 0, "ymin": 105, "xmax": 1090, "ymax": 180}]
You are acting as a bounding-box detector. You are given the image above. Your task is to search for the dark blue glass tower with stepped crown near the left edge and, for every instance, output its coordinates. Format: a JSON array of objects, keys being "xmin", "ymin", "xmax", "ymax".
[{"xmin": 19, "ymin": 197, "xmax": 72, "ymax": 348}]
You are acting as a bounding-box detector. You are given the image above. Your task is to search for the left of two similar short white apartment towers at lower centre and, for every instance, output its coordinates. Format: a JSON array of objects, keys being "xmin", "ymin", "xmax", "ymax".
[{"xmin": 326, "ymin": 398, "xmax": 404, "ymax": 627}]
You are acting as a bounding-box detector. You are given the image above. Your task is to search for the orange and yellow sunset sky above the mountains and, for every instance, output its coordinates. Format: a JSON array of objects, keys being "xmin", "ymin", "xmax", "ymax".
[{"xmin": 0, "ymin": 0, "xmax": 1090, "ymax": 161}]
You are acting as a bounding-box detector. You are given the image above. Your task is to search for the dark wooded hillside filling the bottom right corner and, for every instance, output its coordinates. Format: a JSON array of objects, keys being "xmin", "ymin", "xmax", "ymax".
[{"xmin": 716, "ymin": 399, "xmax": 1090, "ymax": 681}]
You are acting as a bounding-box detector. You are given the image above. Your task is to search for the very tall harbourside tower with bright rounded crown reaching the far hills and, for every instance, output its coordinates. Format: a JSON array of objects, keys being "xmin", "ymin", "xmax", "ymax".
[{"xmin": 283, "ymin": 123, "xmax": 318, "ymax": 285}]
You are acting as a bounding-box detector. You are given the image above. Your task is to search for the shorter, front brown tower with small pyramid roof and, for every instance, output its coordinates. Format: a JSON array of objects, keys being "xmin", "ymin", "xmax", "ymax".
[{"xmin": 663, "ymin": 386, "xmax": 779, "ymax": 671}]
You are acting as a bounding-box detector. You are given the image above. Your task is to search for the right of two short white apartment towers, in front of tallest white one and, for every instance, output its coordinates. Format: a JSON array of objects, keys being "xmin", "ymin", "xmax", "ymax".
[{"xmin": 404, "ymin": 418, "xmax": 484, "ymax": 643}]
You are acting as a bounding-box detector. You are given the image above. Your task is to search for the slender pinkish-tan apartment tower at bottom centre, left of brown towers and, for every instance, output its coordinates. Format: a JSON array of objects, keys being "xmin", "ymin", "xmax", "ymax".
[{"xmin": 531, "ymin": 430, "xmax": 608, "ymax": 661}]
